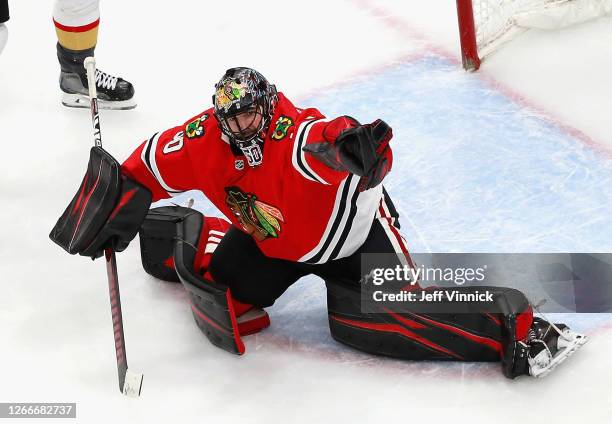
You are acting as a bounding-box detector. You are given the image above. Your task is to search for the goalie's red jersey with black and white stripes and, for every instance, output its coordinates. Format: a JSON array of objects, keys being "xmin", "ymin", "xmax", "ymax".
[{"xmin": 123, "ymin": 93, "xmax": 395, "ymax": 263}]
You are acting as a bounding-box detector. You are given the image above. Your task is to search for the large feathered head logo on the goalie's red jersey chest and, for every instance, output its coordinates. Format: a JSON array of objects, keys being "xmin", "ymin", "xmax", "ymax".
[{"xmin": 225, "ymin": 187, "xmax": 284, "ymax": 241}]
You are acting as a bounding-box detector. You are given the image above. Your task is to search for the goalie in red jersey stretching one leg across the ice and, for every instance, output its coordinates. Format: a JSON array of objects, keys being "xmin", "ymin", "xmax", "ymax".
[{"xmin": 52, "ymin": 67, "xmax": 586, "ymax": 378}]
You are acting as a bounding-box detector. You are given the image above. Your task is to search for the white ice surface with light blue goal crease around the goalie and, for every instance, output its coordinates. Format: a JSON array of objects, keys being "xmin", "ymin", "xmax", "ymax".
[{"xmin": 0, "ymin": 0, "xmax": 612, "ymax": 423}]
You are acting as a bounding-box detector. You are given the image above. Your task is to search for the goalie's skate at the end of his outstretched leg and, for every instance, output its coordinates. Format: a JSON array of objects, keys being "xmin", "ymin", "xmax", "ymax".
[{"xmin": 527, "ymin": 321, "xmax": 588, "ymax": 378}]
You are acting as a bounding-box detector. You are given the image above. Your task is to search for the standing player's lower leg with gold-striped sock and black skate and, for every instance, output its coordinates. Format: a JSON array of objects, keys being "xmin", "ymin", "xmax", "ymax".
[{"xmin": 53, "ymin": 0, "xmax": 136, "ymax": 109}]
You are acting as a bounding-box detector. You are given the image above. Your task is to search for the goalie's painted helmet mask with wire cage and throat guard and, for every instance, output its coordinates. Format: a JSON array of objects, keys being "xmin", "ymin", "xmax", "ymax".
[{"xmin": 213, "ymin": 67, "xmax": 278, "ymax": 166}]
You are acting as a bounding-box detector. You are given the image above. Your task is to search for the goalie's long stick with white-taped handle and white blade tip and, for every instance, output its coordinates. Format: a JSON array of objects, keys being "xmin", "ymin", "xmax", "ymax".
[{"xmin": 84, "ymin": 57, "xmax": 143, "ymax": 397}]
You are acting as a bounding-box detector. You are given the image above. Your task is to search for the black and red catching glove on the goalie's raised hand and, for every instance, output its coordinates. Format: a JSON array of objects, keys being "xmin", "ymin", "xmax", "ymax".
[{"xmin": 303, "ymin": 117, "xmax": 393, "ymax": 191}]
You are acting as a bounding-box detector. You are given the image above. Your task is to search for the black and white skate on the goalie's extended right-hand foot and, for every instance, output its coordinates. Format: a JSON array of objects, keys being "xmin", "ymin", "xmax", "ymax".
[{"xmin": 519, "ymin": 317, "xmax": 588, "ymax": 377}]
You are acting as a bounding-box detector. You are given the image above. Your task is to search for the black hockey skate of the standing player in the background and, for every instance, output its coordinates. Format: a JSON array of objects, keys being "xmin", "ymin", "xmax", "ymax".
[{"xmin": 57, "ymin": 43, "xmax": 136, "ymax": 110}]
